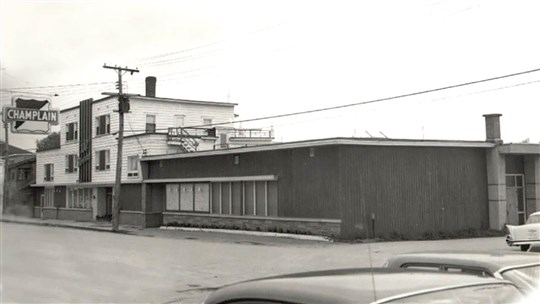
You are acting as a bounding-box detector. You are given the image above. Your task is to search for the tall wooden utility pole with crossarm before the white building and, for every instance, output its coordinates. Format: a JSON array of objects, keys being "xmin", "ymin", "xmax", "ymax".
[{"xmin": 103, "ymin": 64, "xmax": 139, "ymax": 231}]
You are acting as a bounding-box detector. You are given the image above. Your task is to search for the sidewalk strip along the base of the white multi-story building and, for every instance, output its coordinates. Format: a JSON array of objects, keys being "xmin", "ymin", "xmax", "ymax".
[{"xmin": 0, "ymin": 214, "xmax": 143, "ymax": 234}]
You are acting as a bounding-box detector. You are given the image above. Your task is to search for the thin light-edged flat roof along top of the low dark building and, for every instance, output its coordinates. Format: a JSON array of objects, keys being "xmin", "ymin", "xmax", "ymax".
[{"xmin": 141, "ymin": 137, "xmax": 495, "ymax": 161}]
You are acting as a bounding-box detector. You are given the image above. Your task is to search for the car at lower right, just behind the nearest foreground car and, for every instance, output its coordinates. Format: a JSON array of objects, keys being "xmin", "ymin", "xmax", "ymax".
[{"xmin": 383, "ymin": 251, "xmax": 540, "ymax": 292}]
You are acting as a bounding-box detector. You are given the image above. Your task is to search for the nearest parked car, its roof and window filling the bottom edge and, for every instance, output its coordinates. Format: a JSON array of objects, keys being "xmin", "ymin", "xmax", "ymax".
[{"xmin": 204, "ymin": 268, "xmax": 523, "ymax": 304}]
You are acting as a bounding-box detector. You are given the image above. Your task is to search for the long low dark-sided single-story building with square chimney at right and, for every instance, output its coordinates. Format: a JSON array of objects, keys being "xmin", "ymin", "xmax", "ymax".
[{"xmin": 136, "ymin": 116, "xmax": 540, "ymax": 239}]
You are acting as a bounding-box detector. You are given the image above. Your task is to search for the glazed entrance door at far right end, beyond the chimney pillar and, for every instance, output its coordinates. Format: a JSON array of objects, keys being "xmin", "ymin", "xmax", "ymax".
[{"xmin": 506, "ymin": 174, "xmax": 527, "ymax": 225}]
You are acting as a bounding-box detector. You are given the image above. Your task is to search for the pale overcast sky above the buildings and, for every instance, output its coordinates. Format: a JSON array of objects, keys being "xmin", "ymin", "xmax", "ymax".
[{"xmin": 0, "ymin": 0, "xmax": 540, "ymax": 149}]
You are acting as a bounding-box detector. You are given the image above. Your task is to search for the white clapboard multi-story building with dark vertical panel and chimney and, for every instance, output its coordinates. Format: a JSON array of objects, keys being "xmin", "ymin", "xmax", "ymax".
[{"xmin": 34, "ymin": 77, "xmax": 273, "ymax": 227}]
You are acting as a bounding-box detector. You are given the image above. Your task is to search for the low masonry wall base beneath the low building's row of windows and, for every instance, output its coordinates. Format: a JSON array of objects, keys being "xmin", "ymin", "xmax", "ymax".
[{"xmin": 163, "ymin": 212, "xmax": 341, "ymax": 237}]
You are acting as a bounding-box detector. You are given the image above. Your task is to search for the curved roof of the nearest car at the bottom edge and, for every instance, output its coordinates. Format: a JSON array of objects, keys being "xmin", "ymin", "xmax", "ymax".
[{"xmin": 204, "ymin": 268, "xmax": 510, "ymax": 304}]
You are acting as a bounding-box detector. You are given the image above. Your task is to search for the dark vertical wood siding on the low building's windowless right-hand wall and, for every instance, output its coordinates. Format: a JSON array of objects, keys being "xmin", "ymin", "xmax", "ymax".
[{"xmin": 340, "ymin": 146, "xmax": 488, "ymax": 238}]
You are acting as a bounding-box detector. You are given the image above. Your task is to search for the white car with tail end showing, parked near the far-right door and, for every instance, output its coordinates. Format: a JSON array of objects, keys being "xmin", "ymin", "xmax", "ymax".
[{"xmin": 506, "ymin": 211, "xmax": 540, "ymax": 251}]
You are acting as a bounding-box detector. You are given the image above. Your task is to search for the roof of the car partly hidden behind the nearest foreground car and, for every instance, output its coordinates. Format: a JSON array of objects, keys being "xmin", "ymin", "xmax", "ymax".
[{"xmin": 385, "ymin": 251, "xmax": 540, "ymax": 274}]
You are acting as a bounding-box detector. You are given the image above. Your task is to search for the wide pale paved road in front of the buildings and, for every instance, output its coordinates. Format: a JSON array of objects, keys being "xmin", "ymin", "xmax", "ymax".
[{"xmin": 0, "ymin": 223, "xmax": 517, "ymax": 303}]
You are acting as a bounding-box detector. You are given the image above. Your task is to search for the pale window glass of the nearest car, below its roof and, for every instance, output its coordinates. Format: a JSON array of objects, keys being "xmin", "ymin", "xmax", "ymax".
[{"xmin": 383, "ymin": 284, "xmax": 523, "ymax": 304}]
